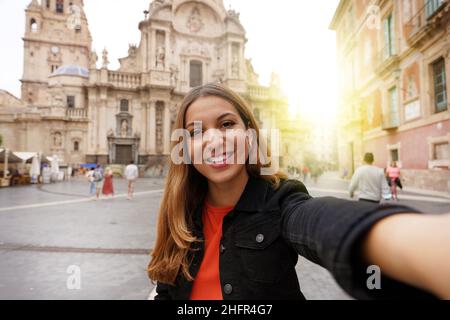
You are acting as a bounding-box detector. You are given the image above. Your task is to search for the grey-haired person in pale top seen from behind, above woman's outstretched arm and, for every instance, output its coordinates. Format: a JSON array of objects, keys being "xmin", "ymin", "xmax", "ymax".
[{"xmin": 349, "ymin": 153, "xmax": 390, "ymax": 203}]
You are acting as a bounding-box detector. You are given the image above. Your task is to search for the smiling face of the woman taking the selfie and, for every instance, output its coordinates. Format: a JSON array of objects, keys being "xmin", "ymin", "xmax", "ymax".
[{"xmin": 185, "ymin": 96, "xmax": 248, "ymax": 183}]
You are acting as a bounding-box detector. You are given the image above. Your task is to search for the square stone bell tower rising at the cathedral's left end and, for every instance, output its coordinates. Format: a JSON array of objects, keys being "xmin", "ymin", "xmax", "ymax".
[{"xmin": 21, "ymin": 0, "xmax": 92, "ymax": 105}]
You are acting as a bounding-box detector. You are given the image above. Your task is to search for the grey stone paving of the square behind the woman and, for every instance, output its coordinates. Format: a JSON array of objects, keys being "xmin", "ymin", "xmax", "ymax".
[{"xmin": 0, "ymin": 174, "xmax": 450, "ymax": 299}]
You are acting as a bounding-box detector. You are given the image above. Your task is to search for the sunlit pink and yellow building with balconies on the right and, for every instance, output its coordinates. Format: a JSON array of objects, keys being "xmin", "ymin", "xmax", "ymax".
[{"xmin": 330, "ymin": 0, "xmax": 450, "ymax": 191}]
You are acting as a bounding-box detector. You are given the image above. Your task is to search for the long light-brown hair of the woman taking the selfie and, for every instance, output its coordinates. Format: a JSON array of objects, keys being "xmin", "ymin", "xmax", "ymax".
[{"xmin": 147, "ymin": 84, "xmax": 284, "ymax": 285}]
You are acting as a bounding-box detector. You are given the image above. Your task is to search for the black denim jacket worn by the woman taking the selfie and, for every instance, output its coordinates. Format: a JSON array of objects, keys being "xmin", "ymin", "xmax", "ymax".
[{"xmin": 155, "ymin": 177, "xmax": 433, "ymax": 300}]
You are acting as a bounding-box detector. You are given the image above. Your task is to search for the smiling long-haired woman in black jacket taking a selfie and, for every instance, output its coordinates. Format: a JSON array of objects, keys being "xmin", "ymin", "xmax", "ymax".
[{"xmin": 148, "ymin": 84, "xmax": 450, "ymax": 300}]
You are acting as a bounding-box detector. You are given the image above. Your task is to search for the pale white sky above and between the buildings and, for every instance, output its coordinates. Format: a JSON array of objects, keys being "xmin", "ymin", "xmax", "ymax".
[{"xmin": 0, "ymin": 0, "xmax": 339, "ymax": 117}]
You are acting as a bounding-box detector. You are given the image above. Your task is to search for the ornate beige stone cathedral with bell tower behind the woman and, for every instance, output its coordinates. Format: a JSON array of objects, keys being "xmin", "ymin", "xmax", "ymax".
[{"xmin": 0, "ymin": 0, "xmax": 294, "ymax": 175}]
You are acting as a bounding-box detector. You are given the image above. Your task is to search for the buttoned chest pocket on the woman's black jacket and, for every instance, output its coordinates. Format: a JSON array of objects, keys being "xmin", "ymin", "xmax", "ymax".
[{"xmin": 235, "ymin": 213, "xmax": 290, "ymax": 283}]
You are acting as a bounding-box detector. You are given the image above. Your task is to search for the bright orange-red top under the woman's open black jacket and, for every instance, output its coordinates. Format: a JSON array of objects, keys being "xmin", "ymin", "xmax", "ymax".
[{"xmin": 190, "ymin": 202, "xmax": 234, "ymax": 300}]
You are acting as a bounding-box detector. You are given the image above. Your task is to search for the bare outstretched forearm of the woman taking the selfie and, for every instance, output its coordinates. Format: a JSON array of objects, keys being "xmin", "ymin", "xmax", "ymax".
[{"xmin": 362, "ymin": 214, "xmax": 450, "ymax": 299}]
